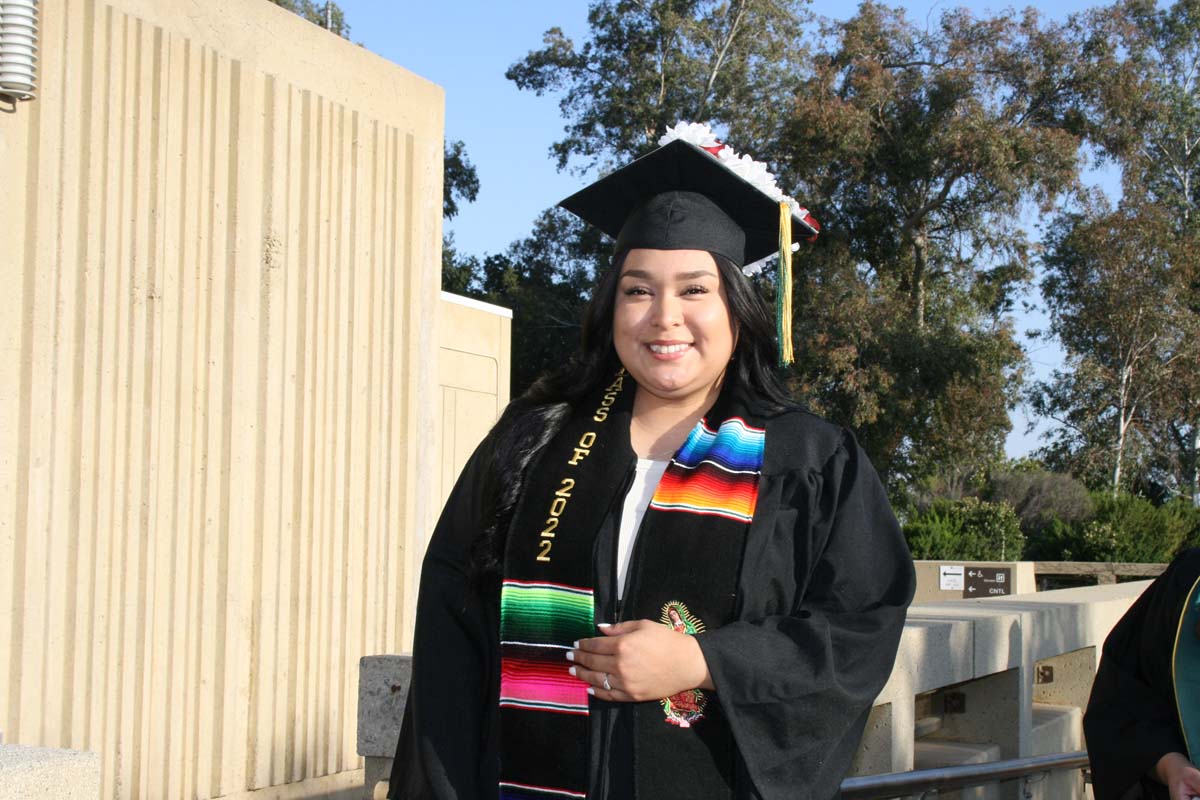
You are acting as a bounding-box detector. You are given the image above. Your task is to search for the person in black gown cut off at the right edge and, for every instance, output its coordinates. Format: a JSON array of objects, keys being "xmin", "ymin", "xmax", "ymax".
[{"xmin": 1084, "ymin": 549, "xmax": 1200, "ymax": 800}]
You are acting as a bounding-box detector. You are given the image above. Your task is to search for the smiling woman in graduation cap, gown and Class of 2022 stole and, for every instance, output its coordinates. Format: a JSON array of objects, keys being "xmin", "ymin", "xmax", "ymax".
[{"xmin": 389, "ymin": 124, "xmax": 914, "ymax": 800}]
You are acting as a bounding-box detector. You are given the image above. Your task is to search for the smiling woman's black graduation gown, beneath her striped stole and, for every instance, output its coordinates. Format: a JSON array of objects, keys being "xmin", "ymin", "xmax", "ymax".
[{"xmin": 389, "ymin": 411, "xmax": 916, "ymax": 800}]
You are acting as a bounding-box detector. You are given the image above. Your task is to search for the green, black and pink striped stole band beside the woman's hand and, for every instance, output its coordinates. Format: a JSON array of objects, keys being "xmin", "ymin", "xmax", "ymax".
[{"xmin": 500, "ymin": 579, "xmax": 595, "ymax": 715}]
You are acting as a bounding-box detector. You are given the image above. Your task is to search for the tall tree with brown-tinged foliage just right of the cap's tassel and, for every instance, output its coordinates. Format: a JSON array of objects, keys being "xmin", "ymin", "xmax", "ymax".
[{"xmin": 774, "ymin": 2, "xmax": 1079, "ymax": 485}]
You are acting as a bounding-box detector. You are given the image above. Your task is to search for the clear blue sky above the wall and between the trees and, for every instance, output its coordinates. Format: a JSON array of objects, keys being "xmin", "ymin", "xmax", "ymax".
[{"xmin": 337, "ymin": 0, "xmax": 1098, "ymax": 456}]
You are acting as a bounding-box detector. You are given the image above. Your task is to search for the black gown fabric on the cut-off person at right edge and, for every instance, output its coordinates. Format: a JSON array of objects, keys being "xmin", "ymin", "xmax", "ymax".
[{"xmin": 1084, "ymin": 549, "xmax": 1200, "ymax": 800}]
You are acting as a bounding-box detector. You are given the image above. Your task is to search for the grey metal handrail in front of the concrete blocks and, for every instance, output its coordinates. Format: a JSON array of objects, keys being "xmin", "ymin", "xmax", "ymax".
[{"xmin": 841, "ymin": 750, "xmax": 1087, "ymax": 800}]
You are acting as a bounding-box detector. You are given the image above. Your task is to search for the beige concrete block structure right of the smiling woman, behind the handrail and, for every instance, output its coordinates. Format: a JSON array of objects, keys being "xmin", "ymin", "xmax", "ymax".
[{"xmin": 859, "ymin": 582, "xmax": 1150, "ymax": 800}]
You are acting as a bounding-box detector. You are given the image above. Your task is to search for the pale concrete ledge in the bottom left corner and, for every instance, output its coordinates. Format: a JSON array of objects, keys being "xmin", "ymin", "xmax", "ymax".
[{"xmin": 0, "ymin": 745, "xmax": 100, "ymax": 800}]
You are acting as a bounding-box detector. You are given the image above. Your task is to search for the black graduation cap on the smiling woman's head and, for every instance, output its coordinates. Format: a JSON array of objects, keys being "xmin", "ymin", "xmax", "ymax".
[{"xmin": 559, "ymin": 139, "xmax": 817, "ymax": 266}]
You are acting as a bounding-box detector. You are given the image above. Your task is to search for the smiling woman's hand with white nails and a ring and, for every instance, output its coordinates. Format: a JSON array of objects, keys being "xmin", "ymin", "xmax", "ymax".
[{"xmin": 568, "ymin": 619, "xmax": 713, "ymax": 703}]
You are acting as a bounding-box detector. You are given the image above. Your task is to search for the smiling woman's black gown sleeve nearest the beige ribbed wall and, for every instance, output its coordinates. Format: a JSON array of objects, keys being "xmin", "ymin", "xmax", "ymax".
[{"xmin": 388, "ymin": 437, "xmax": 499, "ymax": 800}]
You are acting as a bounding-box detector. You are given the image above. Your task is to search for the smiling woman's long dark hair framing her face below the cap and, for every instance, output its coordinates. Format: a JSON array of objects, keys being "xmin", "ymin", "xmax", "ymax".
[{"xmin": 521, "ymin": 251, "xmax": 796, "ymax": 409}]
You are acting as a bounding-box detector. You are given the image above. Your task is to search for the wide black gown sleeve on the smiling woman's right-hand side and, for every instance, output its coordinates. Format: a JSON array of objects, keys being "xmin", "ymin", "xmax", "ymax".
[{"xmin": 697, "ymin": 434, "xmax": 916, "ymax": 800}]
